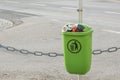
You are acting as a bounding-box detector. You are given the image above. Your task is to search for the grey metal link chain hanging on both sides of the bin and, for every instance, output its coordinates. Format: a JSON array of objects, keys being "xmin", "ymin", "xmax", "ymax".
[{"xmin": 0, "ymin": 44, "xmax": 120, "ymax": 57}]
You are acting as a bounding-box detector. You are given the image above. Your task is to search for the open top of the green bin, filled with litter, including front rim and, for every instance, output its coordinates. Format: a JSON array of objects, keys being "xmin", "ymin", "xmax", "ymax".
[{"xmin": 62, "ymin": 24, "xmax": 93, "ymax": 35}]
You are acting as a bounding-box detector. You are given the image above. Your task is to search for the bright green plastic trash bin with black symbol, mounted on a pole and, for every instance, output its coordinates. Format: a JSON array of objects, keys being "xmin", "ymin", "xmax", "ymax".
[{"xmin": 62, "ymin": 24, "xmax": 93, "ymax": 75}]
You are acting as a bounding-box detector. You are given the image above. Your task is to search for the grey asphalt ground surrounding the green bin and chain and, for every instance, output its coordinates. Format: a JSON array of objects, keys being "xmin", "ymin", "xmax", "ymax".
[{"xmin": 0, "ymin": 0, "xmax": 120, "ymax": 80}]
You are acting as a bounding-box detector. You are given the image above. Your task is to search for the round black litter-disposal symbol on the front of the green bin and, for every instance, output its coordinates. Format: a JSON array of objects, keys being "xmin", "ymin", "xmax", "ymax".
[{"xmin": 67, "ymin": 39, "xmax": 81, "ymax": 54}]
